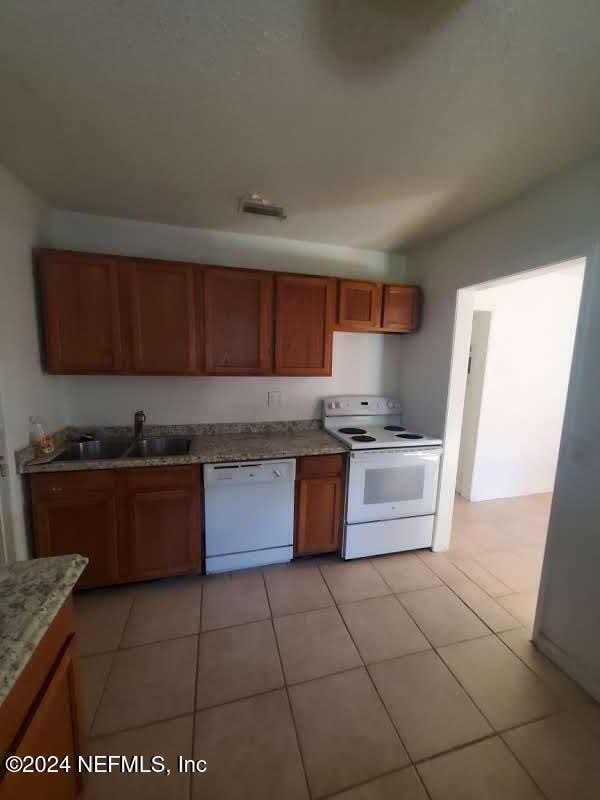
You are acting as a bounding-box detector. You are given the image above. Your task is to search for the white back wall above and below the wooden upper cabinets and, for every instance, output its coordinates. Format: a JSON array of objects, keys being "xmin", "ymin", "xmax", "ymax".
[{"xmin": 44, "ymin": 211, "xmax": 405, "ymax": 425}]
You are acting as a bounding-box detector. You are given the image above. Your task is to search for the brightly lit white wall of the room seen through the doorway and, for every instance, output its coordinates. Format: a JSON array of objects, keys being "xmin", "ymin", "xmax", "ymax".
[{"xmin": 463, "ymin": 259, "xmax": 585, "ymax": 501}]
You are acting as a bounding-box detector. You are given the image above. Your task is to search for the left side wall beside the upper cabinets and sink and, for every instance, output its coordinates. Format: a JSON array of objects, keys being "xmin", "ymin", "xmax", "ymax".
[{"xmin": 0, "ymin": 165, "xmax": 66, "ymax": 559}]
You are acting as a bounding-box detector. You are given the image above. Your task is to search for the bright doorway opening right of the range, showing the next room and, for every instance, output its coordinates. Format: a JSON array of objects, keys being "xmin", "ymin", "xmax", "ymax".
[{"xmin": 434, "ymin": 258, "xmax": 586, "ymax": 628}]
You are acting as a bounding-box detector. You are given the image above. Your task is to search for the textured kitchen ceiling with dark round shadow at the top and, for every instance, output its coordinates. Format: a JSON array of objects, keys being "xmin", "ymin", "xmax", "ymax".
[{"xmin": 0, "ymin": 0, "xmax": 600, "ymax": 250}]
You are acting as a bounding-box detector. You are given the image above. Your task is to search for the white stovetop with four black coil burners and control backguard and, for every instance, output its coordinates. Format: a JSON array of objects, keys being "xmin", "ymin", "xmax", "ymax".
[{"xmin": 323, "ymin": 395, "xmax": 442, "ymax": 450}]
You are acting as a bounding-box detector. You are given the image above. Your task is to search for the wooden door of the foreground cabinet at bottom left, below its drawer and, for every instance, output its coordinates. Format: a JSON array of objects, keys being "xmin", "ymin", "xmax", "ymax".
[{"xmin": 0, "ymin": 642, "xmax": 81, "ymax": 800}]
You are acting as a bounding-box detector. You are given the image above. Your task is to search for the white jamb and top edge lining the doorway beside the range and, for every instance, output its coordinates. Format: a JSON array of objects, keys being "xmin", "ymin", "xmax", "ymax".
[{"xmin": 432, "ymin": 258, "xmax": 586, "ymax": 551}]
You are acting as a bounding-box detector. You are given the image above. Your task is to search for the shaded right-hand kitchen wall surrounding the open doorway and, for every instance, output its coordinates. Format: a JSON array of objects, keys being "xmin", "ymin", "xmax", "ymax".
[{"xmin": 399, "ymin": 152, "xmax": 600, "ymax": 699}]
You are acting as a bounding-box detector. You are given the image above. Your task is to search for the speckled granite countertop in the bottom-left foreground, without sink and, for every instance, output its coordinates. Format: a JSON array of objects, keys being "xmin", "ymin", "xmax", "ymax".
[{"xmin": 0, "ymin": 555, "xmax": 88, "ymax": 704}]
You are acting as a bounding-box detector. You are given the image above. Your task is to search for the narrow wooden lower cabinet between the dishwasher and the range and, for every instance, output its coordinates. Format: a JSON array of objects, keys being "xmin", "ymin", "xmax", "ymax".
[{"xmin": 294, "ymin": 455, "xmax": 344, "ymax": 556}]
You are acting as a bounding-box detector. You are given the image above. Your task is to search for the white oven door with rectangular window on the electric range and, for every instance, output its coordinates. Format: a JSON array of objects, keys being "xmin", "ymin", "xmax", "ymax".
[{"xmin": 346, "ymin": 447, "xmax": 442, "ymax": 525}]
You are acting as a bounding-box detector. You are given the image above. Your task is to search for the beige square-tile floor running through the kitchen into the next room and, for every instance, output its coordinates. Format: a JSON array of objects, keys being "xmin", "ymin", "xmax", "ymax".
[{"xmin": 76, "ymin": 495, "xmax": 600, "ymax": 800}]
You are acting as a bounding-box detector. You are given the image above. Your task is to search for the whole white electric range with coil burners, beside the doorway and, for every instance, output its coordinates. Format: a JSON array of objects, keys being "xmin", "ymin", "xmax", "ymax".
[{"xmin": 323, "ymin": 395, "xmax": 442, "ymax": 559}]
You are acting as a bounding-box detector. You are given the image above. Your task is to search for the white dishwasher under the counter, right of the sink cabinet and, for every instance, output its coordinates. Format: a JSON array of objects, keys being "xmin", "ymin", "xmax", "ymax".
[{"xmin": 204, "ymin": 458, "xmax": 296, "ymax": 573}]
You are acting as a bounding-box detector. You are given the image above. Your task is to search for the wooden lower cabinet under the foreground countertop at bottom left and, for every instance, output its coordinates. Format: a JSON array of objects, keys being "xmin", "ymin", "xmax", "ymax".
[{"xmin": 0, "ymin": 598, "xmax": 83, "ymax": 800}]
